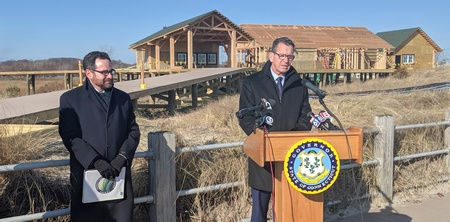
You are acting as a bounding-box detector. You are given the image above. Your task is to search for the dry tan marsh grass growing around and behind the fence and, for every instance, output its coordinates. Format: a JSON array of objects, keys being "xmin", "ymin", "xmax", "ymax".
[{"xmin": 0, "ymin": 67, "xmax": 450, "ymax": 221}]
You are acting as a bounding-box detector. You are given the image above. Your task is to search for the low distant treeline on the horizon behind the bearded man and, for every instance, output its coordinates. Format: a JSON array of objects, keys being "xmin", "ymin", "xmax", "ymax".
[{"xmin": 0, "ymin": 58, "xmax": 133, "ymax": 72}]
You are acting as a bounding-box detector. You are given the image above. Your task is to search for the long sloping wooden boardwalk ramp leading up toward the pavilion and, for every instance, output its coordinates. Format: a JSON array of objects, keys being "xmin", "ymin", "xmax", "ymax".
[{"xmin": 0, "ymin": 68, "xmax": 255, "ymax": 124}]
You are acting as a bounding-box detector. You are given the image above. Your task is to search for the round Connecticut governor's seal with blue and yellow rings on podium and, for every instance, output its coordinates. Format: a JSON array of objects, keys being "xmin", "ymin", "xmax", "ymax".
[{"xmin": 283, "ymin": 138, "xmax": 340, "ymax": 194}]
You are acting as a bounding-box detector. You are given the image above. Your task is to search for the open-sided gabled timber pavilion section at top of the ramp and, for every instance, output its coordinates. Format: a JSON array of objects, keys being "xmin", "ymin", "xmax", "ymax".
[{"xmin": 130, "ymin": 10, "xmax": 253, "ymax": 70}]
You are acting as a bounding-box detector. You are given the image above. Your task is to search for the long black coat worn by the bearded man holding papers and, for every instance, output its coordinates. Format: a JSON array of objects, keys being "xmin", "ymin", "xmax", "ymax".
[{"xmin": 59, "ymin": 79, "xmax": 140, "ymax": 221}]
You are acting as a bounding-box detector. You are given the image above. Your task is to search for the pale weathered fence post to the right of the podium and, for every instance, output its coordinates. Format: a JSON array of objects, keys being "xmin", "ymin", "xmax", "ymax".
[{"xmin": 374, "ymin": 115, "xmax": 395, "ymax": 203}]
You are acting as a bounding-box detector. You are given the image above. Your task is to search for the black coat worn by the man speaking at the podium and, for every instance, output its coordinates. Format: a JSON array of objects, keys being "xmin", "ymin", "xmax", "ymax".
[{"xmin": 239, "ymin": 61, "xmax": 311, "ymax": 191}]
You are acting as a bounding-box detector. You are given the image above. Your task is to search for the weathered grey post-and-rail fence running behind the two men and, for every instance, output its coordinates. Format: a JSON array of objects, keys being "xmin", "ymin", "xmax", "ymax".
[{"xmin": 0, "ymin": 112, "xmax": 450, "ymax": 222}]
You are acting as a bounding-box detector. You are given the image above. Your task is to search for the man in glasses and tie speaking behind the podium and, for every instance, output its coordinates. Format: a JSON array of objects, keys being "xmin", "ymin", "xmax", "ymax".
[{"xmin": 239, "ymin": 37, "xmax": 312, "ymax": 222}]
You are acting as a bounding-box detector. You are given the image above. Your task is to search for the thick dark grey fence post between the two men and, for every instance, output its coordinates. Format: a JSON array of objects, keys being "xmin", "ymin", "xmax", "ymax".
[{"xmin": 148, "ymin": 132, "xmax": 177, "ymax": 222}]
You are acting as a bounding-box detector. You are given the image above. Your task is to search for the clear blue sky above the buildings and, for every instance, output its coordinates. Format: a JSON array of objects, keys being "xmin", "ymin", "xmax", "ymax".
[{"xmin": 0, "ymin": 0, "xmax": 450, "ymax": 63}]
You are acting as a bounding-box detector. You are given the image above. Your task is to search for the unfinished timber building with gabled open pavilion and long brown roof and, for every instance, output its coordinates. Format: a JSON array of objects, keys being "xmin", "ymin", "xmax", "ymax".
[{"xmin": 130, "ymin": 10, "xmax": 394, "ymax": 73}]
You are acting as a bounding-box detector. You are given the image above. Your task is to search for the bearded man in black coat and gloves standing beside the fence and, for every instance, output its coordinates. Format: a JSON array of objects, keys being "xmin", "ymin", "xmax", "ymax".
[{"xmin": 59, "ymin": 51, "xmax": 140, "ymax": 222}]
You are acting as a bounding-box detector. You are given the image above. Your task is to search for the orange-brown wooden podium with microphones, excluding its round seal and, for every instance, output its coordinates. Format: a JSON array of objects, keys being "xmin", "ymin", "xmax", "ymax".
[{"xmin": 244, "ymin": 127, "xmax": 363, "ymax": 222}]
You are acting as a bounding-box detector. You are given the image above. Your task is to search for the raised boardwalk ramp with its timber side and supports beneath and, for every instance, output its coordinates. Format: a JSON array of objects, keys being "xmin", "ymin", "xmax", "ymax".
[{"xmin": 0, "ymin": 68, "xmax": 256, "ymax": 123}]
